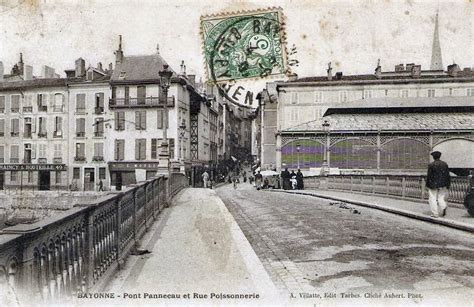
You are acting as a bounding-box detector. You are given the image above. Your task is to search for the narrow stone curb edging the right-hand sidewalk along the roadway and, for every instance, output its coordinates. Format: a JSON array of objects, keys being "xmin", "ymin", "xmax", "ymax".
[{"xmin": 269, "ymin": 190, "xmax": 474, "ymax": 233}]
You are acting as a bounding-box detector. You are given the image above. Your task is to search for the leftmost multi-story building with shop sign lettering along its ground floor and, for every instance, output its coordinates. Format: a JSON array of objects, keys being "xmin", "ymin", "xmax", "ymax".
[{"xmin": 0, "ymin": 55, "xmax": 69, "ymax": 190}]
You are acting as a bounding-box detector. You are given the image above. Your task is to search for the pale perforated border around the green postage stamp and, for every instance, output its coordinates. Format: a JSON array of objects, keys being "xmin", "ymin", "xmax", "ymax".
[{"xmin": 199, "ymin": 6, "xmax": 292, "ymax": 84}]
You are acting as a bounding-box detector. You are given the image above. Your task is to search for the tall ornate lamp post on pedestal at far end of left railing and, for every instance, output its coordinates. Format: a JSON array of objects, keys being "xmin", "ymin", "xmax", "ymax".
[{"xmin": 158, "ymin": 64, "xmax": 173, "ymax": 175}]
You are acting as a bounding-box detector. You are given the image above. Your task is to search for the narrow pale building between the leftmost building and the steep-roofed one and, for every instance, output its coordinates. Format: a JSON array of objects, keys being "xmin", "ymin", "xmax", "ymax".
[{"xmin": 66, "ymin": 58, "xmax": 113, "ymax": 191}]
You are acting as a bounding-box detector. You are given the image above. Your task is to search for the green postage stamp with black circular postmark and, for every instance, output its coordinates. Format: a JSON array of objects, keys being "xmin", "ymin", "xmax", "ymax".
[{"xmin": 201, "ymin": 8, "xmax": 287, "ymax": 83}]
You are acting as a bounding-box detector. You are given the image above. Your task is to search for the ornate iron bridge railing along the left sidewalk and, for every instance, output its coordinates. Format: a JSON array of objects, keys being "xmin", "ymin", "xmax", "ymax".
[{"xmin": 0, "ymin": 173, "xmax": 187, "ymax": 302}]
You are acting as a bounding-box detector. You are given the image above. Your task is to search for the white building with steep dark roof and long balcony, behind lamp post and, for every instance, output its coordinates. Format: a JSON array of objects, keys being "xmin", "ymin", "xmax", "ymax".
[{"xmin": 104, "ymin": 37, "xmax": 196, "ymax": 187}]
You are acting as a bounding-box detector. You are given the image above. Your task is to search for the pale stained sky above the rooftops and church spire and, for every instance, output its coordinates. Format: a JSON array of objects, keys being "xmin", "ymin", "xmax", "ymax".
[{"xmin": 0, "ymin": 0, "xmax": 474, "ymax": 104}]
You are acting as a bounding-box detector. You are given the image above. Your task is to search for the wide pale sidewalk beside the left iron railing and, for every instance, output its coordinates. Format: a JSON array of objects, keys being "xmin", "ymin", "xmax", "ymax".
[{"xmin": 107, "ymin": 188, "xmax": 278, "ymax": 305}]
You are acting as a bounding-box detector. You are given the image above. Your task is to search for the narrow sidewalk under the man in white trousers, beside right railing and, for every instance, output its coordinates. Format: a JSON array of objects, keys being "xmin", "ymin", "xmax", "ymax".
[{"xmin": 269, "ymin": 190, "xmax": 474, "ymax": 232}]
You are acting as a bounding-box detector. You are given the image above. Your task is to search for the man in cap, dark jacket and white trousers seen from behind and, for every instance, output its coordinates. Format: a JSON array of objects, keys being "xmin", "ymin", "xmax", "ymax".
[{"xmin": 426, "ymin": 151, "xmax": 451, "ymax": 217}]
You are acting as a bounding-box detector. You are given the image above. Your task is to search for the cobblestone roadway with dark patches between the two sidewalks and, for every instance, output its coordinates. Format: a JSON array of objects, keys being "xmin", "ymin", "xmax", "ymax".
[{"xmin": 217, "ymin": 184, "xmax": 474, "ymax": 303}]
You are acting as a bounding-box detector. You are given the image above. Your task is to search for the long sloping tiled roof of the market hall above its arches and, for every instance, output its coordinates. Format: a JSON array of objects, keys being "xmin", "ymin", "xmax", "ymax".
[{"xmin": 281, "ymin": 112, "xmax": 474, "ymax": 133}]
